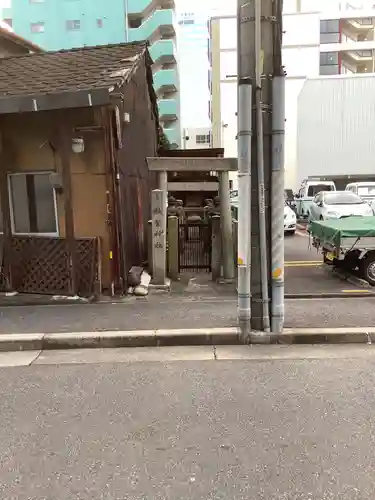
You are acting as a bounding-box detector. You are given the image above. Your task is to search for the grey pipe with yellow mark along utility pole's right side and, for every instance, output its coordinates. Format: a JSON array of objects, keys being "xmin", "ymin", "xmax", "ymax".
[{"xmin": 271, "ymin": 76, "xmax": 285, "ymax": 333}]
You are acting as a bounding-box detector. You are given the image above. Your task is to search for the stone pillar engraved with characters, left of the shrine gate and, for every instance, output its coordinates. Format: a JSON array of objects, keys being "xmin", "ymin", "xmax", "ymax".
[{"xmin": 151, "ymin": 189, "xmax": 167, "ymax": 285}]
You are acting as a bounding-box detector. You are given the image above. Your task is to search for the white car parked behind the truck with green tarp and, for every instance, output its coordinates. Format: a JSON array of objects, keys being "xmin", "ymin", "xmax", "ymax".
[{"xmin": 310, "ymin": 191, "xmax": 374, "ymax": 221}]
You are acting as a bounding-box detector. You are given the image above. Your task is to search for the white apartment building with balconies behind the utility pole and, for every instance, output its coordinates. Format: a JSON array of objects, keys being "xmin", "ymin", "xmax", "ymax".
[{"xmin": 210, "ymin": 0, "xmax": 375, "ymax": 187}]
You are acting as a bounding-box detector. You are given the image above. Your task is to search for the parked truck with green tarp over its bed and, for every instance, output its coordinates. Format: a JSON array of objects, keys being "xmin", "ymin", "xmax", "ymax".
[{"xmin": 308, "ymin": 217, "xmax": 375, "ymax": 286}]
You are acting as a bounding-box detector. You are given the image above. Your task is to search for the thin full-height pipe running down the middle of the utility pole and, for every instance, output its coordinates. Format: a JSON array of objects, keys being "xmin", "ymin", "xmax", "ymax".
[{"xmin": 255, "ymin": 0, "xmax": 270, "ymax": 332}]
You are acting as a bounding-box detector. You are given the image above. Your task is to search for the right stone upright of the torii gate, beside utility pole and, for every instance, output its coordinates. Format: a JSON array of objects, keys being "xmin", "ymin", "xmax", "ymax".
[{"xmin": 220, "ymin": 172, "xmax": 234, "ymax": 280}]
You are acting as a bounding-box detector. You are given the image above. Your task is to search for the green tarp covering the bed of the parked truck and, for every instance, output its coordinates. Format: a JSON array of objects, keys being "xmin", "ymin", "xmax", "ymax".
[{"xmin": 308, "ymin": 217, "xmax": 375, "ymax": 247}]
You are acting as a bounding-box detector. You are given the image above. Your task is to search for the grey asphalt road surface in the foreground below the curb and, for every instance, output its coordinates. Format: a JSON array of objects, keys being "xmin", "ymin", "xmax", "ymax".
[{"xmin": 0, "ymin": 347, "xmax": 375, "ymax": 500}]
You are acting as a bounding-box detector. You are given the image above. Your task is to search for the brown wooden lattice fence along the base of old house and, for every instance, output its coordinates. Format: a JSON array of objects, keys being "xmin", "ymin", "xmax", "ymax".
[{"xmin": 0, "ymin": 236, "xmax": 98, "ymax": 296}]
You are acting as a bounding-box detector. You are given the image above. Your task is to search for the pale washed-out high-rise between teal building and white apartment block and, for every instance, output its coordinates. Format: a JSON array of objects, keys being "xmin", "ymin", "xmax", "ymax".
[{"xmin": 178, "ymin": 12, "xmax": 210, "ymax": 137}]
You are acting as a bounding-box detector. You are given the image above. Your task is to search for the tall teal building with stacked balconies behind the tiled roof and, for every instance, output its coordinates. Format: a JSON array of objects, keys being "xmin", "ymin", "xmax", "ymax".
[{"xmin": 2, "ymin": 0, "xmax": 181, "ymax": 148}]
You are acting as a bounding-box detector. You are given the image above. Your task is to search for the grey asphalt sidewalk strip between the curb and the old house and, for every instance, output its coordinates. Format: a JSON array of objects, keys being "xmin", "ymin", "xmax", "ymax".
[{"xmin": 0, "ymin": 296, "xmax": 375, "ymax": 334}]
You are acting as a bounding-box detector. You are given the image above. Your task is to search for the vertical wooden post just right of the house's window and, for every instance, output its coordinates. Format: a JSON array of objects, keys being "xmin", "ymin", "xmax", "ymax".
[{"xmin": 59, "ymin": 122, "xmax": 78, "ymax": 296}]
